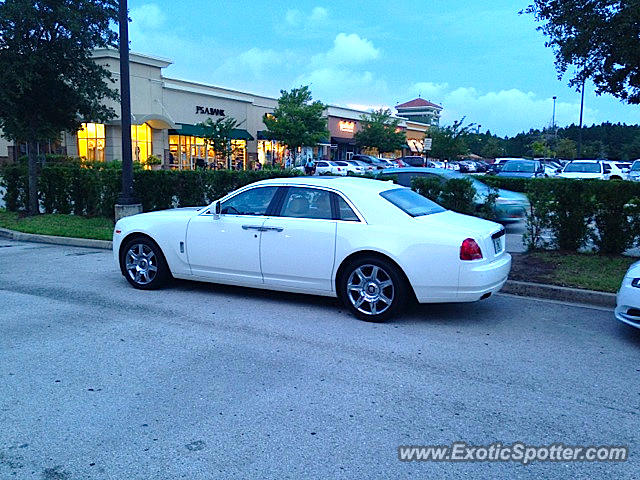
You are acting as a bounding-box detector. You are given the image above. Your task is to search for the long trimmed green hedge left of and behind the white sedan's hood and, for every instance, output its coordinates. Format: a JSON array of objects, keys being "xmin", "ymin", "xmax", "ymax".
[{"xmin": 0, "ymin": 163, "xmax": 300, "ymax": 217}]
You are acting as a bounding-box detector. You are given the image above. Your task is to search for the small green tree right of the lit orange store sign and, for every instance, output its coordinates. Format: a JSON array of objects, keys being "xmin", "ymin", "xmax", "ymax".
[{"xmin": 354, "ymin": 108, "xmax": 407, "ymax": 153}]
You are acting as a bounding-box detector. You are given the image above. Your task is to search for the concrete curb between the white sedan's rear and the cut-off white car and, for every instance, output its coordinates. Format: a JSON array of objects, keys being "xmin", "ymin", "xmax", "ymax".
[{"xmin": 500, "ymin": 280, "xmax": 616, "ymax": 308}]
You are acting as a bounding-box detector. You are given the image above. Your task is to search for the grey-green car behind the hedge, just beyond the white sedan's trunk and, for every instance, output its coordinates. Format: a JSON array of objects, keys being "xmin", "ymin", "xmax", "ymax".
[{"xmin": 381, "ymin": 167, "xmax": 530, "ymax": 223}]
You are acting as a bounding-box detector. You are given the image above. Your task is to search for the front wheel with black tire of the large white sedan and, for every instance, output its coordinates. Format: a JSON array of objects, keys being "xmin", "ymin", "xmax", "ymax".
[{"xmin": 120, "ymin": 236, "xmax": 171, "ymax": 290}]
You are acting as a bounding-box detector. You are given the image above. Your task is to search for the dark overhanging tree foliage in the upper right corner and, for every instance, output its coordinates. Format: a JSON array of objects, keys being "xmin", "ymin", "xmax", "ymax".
[{"xmin": 525, "ymin": 0, "xmax": 640, "ymax": 104}]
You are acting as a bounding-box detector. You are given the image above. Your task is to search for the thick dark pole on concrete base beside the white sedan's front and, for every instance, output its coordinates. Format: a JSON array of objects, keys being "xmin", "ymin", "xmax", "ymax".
[{"xmin": 115, "ymin": 0, "xmax": 142, "ymax": 221}]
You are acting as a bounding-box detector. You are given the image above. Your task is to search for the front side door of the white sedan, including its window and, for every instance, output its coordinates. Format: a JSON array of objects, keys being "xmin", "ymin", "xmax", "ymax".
[{"xmin": 186, "ymin": 187, "xmax": 277, "ymax": 285}]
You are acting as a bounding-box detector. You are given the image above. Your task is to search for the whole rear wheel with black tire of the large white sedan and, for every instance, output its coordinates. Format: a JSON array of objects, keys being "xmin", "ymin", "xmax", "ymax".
[{"xmin": 337, "ymin": 256, "xmax": 409, "ymax": 323}]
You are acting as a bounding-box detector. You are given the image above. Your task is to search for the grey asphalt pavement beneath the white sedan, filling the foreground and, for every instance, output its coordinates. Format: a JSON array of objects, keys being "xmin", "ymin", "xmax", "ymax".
[{"xmin": 0, "ymin": 240, "xmax": 640, "ymax": 480}]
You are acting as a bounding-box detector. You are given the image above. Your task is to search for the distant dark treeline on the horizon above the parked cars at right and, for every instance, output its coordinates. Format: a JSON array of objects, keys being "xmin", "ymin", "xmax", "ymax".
[{"xmin": 465, "ymin": 123, "xmax": 640, "ymax": 160}]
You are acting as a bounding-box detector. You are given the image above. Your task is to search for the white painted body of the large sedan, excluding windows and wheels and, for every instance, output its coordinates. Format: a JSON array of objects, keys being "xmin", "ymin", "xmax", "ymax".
[{"xmin": 113, "ymin": 177, "xmax": 511, "ymax": 303}]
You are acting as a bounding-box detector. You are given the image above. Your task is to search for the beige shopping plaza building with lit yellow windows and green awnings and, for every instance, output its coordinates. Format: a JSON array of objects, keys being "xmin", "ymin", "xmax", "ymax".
[{"xmin": 0, "ymin": 49, "xmax": 441, "ymax": 169}]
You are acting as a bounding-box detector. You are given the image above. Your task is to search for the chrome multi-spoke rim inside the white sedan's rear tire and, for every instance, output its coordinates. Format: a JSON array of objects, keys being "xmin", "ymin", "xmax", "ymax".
[{"xmin": 347, "ymin": 264, "xmax": 395, "ymax": 315}]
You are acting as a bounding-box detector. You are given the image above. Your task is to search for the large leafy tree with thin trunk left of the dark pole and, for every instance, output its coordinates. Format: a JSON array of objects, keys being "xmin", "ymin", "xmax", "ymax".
[{"xmin": 0, "ymin": 0, "xmax": 118, "ymax": 215}]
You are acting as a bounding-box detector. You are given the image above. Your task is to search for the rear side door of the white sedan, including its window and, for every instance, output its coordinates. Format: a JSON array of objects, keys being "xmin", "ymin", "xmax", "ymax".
[{"xmin": 260, "ymin": 186, "xmax": 338, "ymax": 293}]
